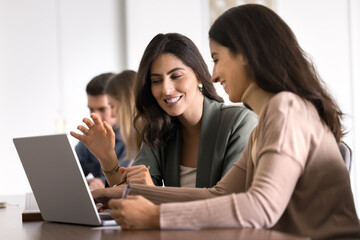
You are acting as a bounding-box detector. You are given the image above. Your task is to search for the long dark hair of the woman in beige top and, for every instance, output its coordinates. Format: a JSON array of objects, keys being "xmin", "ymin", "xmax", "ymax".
[{"xmin": 209, "ymin": 4, "xmax": 344, "ymax": 142}]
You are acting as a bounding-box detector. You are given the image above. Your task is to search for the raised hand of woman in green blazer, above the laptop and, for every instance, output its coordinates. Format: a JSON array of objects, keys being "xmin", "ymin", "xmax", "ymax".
[{"xmin": 70, "ymin": 113, "xmax": 116, "ymax": 164}]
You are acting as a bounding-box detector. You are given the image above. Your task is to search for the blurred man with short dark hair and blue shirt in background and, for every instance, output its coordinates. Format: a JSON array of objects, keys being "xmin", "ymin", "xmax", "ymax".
[{"xmin": 75, "ymin": 73, "xmax": 128, "ymax": 190}]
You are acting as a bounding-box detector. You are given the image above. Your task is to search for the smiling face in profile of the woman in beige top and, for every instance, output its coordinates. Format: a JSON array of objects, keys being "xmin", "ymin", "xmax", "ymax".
[{"xmin": 210, "ymin": 40, "xmax": 252, "ymax": 102}]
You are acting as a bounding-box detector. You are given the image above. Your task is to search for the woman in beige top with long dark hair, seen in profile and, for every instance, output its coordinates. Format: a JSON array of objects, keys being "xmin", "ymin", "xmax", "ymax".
[{"xmin": 81, "ymin": 5, "xmax": 360, "ymax": 239}]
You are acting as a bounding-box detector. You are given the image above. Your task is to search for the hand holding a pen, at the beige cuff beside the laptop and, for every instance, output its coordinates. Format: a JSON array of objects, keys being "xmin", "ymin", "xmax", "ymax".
[{"xmin": 108, "ymin": 195, "xmax": 160, "ymax": 229}]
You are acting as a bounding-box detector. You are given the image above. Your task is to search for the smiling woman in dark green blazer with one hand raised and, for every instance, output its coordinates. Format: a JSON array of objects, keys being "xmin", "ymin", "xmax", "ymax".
[{"xmin": 71, "ymin": 33, "xmax": 257, "ymax": 187}]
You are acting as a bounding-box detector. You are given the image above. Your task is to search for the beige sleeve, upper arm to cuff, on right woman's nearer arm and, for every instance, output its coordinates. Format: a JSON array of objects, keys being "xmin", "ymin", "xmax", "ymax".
[{"xmin": 160, "ymin": 154, "xmax": 301, "ymax": 229}]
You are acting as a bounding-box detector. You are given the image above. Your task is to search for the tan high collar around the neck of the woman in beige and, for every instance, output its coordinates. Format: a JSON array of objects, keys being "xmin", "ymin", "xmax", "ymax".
[{"xmin": 241, "ymin": 83, "xmax": 275, "ymax": 117}]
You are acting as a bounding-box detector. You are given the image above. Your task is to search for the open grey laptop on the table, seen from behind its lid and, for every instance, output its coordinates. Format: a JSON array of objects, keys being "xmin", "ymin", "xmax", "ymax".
[{"xmin": 13, "ymin": 134, "xmax": 115, "ymax": 226}]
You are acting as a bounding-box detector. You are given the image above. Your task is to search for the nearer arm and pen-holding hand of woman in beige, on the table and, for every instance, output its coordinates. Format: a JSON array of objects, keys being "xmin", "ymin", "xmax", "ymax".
[{"xmin": 100, "ymin": 153, "xmax": 302, "ymax": 229}]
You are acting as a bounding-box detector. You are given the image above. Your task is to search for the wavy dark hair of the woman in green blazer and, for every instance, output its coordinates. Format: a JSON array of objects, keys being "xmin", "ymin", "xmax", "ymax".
[{"xmin": 134, "ymin": 33, "xmax": 223, "ymax": 148}]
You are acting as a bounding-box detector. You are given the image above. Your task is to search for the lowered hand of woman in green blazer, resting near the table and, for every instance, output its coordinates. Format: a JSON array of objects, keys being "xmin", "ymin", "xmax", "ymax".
[{"xmin": 120, "ymin": 165, "xmax": 155, "ymax": 186}]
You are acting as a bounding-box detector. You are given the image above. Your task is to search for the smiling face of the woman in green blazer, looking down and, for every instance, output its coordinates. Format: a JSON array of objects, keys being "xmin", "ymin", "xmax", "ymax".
[{"xmin": 150, "ymin": 53, "xmax": 203, "ymax": 118}]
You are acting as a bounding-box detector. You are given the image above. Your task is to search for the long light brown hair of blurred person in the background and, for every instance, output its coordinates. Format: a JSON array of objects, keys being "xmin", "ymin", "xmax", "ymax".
[{"xmin": 105, "ymin": 70, "xmax": 140, "ymax": 160}]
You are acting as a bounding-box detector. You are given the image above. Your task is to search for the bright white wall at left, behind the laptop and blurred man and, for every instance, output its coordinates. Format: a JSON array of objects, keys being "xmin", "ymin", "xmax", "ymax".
[{"xmin": 0, "ymin": 0, "xmax": 123, "ymax": 195}]
